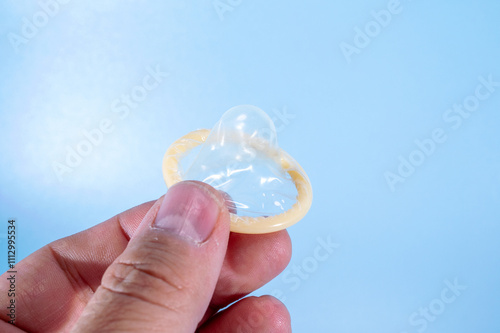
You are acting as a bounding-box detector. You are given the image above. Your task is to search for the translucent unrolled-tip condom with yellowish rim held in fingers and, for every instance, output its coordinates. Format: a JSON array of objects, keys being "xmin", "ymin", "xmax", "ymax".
[{"xmin": 162, "ymin": 105, "xmax": 312, "ymax": 234}]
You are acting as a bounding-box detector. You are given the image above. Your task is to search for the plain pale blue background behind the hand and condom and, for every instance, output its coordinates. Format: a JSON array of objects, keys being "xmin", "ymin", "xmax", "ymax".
[{"xmin": 0, "ymin": 0, "xmax": 500, "ymax": 333}]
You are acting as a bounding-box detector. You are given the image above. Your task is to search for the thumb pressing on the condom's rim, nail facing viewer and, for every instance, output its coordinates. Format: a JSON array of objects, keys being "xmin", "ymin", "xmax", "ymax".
[{"xmin": 73, "ymin": 181, "xmax": 229, "ymax": 332}]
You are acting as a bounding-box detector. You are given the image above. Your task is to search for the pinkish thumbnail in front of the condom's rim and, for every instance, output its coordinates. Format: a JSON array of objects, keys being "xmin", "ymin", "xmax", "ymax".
[{"xmin": 153, "ymin": 181, "xmax": 220, "ymax": 243}]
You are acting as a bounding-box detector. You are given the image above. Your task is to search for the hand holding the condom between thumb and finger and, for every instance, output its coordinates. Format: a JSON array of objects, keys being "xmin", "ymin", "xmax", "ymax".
[{"xmin": 0, "ymin": 181, "xmax": 291, "ymax": 332}]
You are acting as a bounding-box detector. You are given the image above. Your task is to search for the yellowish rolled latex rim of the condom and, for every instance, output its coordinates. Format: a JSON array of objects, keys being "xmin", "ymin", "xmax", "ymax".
[{"xmin": 162, "ymin": 129, "xmax": 312, "ymax": 234}]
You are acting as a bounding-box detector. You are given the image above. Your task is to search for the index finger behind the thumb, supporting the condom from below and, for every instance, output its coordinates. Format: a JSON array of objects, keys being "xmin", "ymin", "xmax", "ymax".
[{"xmin": 0, "ymin": 201, "xmax": 291, "ymax": 332}]
